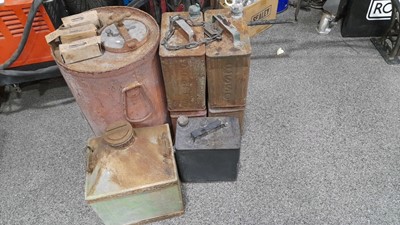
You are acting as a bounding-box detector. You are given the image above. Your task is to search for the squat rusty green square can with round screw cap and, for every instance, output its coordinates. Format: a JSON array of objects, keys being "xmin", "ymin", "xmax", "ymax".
[{"xmin": 85, "ymin": 121, "xmax": 184, "ymax": 224}]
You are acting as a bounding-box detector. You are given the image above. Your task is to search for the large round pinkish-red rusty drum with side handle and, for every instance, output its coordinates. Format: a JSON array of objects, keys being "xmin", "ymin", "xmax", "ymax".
[{"xmin": 53, "ymin": 7, "xmax": 168, "ymax": 135}]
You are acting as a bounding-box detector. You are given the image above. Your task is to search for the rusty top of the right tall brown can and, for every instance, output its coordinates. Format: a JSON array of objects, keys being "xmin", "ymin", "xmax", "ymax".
[{"xmin": 204, "ymin": 9, "xmax": 251, "ymax": 57}]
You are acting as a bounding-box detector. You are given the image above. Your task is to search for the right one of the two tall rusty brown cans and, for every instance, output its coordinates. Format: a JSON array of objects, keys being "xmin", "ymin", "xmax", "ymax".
[{"xmin": 204, "ymin": 9, "xmax": 251, "ymax": 108}]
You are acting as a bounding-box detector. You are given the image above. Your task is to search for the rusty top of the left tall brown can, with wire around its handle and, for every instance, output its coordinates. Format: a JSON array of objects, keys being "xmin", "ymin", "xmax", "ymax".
[{"xmin": 159, "ymin": 12, "xmax": 206, "ymax": 57}]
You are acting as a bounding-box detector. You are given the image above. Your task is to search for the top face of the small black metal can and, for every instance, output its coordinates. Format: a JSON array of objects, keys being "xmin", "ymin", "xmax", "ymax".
[{"xmin": 175, "ymin": 117, "xmax": 241, "ymax": 151}]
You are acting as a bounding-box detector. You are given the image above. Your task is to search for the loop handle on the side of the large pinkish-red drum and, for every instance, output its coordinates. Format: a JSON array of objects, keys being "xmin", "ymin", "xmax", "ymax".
[{"xmin": 122, "ymin": 82, "xmax": 154, "ymax": 123}]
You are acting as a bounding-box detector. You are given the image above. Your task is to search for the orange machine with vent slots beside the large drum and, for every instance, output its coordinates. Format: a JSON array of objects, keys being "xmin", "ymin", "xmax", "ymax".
[{"xmin": 0, "ymin": 0, "xmax": 54, "ymax": 68}]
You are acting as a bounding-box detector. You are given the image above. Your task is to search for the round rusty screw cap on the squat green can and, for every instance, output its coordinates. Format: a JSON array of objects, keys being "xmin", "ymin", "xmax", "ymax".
[{"xmin": 103, "ymin": 121, "xmax": 133, "ymax": 147}]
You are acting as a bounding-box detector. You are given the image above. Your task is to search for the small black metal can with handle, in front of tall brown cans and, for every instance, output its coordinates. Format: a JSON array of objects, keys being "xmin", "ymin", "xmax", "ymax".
[{"xmin": 175, "ymin": 117, "xmax": 241, "ymax": 182}]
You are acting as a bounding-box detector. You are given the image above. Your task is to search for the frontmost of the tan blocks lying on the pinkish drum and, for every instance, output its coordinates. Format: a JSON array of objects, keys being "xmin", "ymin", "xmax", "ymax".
[{"xmin": 59, "ymin": 36, "xmax": 103, "ymax": 64}]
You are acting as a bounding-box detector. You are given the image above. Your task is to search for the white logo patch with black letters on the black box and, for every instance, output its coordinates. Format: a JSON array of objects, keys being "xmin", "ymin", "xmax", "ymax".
[{"xmin": 367, "ymin": 0, "xmax": 392, "ymax": 20}]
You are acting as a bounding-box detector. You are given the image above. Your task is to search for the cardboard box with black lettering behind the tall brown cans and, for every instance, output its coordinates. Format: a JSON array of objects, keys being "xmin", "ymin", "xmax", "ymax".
[{"xmin": 220, "ymin": 0, "xmax": 278, "ymax": 37}]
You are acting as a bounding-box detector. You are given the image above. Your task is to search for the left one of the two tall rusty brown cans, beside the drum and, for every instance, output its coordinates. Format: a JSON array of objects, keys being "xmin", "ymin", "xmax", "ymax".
[{"xmin": 159, "ymin": 12, "xmax": 206, "ymax": 111}]
